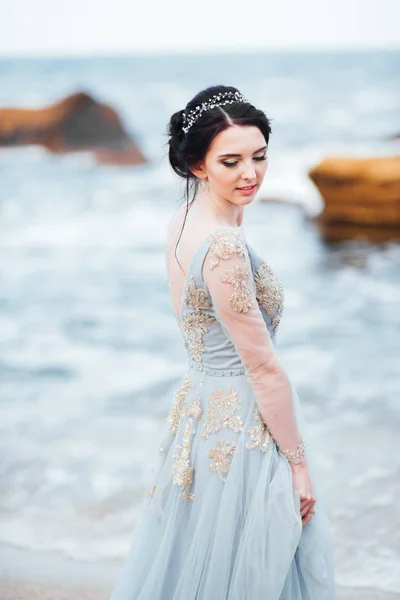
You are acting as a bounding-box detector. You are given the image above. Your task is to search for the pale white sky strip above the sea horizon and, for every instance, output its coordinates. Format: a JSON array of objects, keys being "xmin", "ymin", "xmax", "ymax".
[{"xmin": 0, "ymin": 0, "xmax": 400, "ymax": 56}]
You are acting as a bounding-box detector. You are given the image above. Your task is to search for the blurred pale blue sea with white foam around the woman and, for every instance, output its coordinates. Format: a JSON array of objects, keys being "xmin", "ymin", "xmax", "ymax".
[{"xmin": 0, "ymin": 52, "xmax": 400, "ymax": 593}]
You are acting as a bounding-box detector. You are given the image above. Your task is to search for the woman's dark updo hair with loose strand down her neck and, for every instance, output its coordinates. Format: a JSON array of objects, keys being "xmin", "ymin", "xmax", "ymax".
[{"xmin": 168, "ymin": 85, "xmax": 271, "ymax": 263}]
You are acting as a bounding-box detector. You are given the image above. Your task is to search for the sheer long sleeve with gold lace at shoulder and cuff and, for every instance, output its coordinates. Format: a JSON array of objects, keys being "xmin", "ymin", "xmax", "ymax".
[{"xmin": 203, "ymin": 229, "xmax": 304, "ymax": 464}]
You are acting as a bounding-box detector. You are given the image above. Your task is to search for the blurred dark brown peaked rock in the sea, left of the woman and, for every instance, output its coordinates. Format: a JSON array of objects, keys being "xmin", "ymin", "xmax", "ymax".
[{"xmin": 0, "ymin": 92, "xmax": 147, "ymax": 165}]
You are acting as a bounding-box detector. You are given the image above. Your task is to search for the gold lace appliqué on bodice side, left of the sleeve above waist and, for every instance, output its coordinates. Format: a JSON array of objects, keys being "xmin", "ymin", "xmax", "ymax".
[{"xmin": 181, "ymin": 275, "xmax": 215, "ymax": 363}]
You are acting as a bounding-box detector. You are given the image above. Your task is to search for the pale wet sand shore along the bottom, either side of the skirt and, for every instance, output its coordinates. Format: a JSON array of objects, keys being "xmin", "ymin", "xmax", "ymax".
[{"xmin": 0, "ymin": 543, "xmax": 400, "ymax": 600}]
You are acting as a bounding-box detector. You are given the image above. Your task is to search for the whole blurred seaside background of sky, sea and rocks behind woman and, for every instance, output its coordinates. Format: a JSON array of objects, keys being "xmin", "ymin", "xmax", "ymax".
[{"xmin": 0, "ymin": 0, "xmax": 400, "ymax": 598}]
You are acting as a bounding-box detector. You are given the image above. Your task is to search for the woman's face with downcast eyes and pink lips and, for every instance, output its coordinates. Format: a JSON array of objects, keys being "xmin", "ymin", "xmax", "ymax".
[{"xmin": 195, "ymin": 125, "xmax": 268, "ymax": 206}]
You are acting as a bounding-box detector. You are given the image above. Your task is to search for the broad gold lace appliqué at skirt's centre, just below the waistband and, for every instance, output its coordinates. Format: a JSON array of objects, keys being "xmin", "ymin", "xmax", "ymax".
[{"xmin": 201, "ymin": 388, "xmax": 243, "ymax": 440}]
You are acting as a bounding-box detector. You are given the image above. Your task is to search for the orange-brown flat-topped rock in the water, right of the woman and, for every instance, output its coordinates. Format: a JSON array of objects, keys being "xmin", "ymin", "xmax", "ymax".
[{"xmin": 308, "ymin": 156, "xmax": 400, "ymax": 227}]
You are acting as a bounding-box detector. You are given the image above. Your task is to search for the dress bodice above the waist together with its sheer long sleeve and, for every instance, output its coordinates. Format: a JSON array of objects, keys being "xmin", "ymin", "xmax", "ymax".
[{"xmin": 166, "ymin": 227, "xmax": 303, "ymax": 459}]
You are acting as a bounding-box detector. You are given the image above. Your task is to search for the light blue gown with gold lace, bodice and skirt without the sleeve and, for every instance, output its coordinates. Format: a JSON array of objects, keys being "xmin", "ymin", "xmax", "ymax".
[{"xmin": 110, "ymin": 229, "xmax": 336, "ymax": 600}]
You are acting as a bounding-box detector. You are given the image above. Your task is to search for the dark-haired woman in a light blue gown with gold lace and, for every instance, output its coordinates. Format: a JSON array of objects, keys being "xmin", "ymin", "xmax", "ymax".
[{"xmin": 111, "ymin": 86, "xmax": 335, "ymax": 600}]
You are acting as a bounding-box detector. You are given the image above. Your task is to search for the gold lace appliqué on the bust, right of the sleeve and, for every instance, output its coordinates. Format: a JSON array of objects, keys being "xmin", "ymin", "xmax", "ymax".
[{"xmin": 254, "ymin": 263, "xmax": 284, "ymax": 333}]
